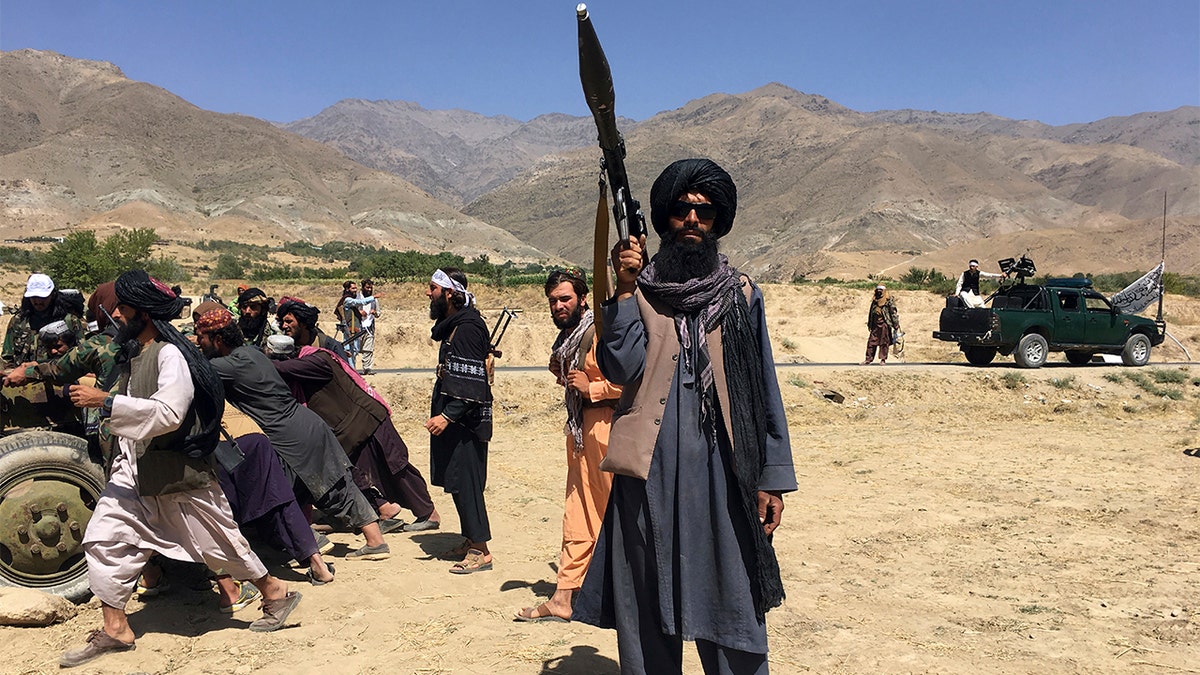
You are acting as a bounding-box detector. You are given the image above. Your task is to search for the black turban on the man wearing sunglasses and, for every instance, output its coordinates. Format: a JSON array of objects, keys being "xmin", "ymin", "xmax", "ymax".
[{"xmin": 650, "ymin": 159, "xmax": 738, "ymax": 238}]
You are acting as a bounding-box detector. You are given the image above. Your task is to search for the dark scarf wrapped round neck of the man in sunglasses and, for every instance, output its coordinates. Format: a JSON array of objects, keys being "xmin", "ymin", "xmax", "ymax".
[{"xmin": 637, "ymin": 255, "xmax": 784, "ymax": 620}]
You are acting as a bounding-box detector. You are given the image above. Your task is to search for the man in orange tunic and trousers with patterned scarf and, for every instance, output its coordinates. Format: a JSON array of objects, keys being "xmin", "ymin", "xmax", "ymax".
[{"xmin": 516, "ymin": 269, "xmax": 620, "ymax": 621}]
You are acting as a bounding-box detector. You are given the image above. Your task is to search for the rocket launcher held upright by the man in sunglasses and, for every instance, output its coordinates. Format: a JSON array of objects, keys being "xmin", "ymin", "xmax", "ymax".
[{"xmin": 575, "ymin": 4, "xmax": 646, "ymax": 319}]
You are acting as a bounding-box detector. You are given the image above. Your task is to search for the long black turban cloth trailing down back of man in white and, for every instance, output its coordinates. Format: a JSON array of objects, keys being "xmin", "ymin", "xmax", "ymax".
[{"xmin": 115, "ymin": 269, "xmax": 224, "ymax": 459}]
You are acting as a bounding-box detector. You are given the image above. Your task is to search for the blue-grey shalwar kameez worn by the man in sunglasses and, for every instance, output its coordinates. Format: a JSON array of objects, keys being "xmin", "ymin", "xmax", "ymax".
[{"xmin": 574, "ymin": 288, "xmax": 796, "ymax": 673}]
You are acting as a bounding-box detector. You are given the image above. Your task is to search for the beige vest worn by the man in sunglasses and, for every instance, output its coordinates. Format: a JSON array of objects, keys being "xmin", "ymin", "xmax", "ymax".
[{"xmin": 600, "ymin": 283, "xmax": 752, "ymax": 480}]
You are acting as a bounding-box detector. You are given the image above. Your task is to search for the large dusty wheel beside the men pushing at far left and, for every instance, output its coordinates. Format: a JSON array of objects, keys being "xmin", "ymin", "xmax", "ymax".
[{"xmin": 0, "ymin": 430, "xmax": 104, "ymax": 602}]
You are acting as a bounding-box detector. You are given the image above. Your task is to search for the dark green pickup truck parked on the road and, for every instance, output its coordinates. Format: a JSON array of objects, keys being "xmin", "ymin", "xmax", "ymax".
[{"xmin": 934, "ymin": 279, "xmax": 1166, "ymax": 368}]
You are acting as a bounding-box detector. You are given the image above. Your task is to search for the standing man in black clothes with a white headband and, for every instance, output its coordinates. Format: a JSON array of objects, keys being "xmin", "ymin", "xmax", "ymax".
[{"xmin": 425, "ymin": 268, "xmax": 492, "ymax": 574}]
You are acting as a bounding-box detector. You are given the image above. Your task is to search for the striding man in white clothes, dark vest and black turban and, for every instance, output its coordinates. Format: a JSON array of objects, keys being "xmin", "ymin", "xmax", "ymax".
[{"xmin": 60, "ymin": 270, "xmax": 300, "ymax": 668}]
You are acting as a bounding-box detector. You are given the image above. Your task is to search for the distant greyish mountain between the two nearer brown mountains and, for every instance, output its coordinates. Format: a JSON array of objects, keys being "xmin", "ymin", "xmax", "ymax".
[{"xmin": 281, "ymin": 98, "xmax": 634, "ymax": 207}]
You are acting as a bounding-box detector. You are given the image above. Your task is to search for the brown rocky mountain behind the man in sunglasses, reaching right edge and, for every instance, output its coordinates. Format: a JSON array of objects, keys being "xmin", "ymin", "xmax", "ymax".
[{"xmin": 464, "ymin": 84, "xmax": 1200, "ymax": 279}]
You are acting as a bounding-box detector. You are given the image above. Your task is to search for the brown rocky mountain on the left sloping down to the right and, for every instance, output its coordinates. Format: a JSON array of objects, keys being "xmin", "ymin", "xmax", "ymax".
[{"xmin": 0, "ymin": 49, "xmax": 546, "ymax": 259}]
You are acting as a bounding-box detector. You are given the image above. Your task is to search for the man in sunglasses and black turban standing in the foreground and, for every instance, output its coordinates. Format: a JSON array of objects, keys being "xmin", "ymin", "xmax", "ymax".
[{"xmin": 574, "ymin": 160, "xmax": 796, "ymax": 673}]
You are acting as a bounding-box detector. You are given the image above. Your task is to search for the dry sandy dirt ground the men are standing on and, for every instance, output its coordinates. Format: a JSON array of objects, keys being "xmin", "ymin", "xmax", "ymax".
[{"xmin": 0, "ymin": 285, "xmax": 1200, "ymax": 675}]
